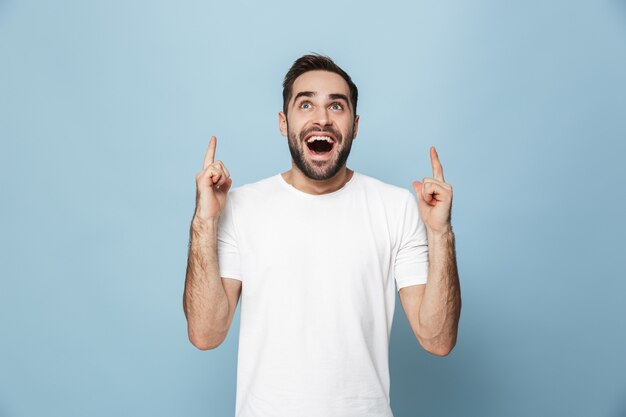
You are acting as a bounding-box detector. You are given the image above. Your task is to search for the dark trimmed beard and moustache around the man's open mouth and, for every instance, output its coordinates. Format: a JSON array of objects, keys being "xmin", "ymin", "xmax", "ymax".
[{"xmin": 287, "ymin": 124, "xmax": 354, "ymax": 181}]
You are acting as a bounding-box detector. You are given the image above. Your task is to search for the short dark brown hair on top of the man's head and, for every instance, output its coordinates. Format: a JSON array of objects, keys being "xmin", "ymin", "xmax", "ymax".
[{"xmin": 283, "ymin": 54, "xmax": 359, "ymax": 116}]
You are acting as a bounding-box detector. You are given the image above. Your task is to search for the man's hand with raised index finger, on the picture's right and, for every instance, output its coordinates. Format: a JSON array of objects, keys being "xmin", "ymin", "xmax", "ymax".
[{"xmin": 413, "ymin": 146, "xmax": 452, "ymax": 233}]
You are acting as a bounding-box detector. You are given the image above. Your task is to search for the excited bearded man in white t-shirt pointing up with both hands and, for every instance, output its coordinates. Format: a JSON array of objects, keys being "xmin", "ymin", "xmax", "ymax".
[{"xmin": 183, "ymin": 55, "xmax": 461, "ymax": 417}]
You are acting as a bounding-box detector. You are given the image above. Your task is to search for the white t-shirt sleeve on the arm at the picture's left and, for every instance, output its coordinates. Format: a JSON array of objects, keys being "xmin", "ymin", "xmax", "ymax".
[{"xmin": 217, "ymin": 196, "xmax": 243, "ymax": 281}]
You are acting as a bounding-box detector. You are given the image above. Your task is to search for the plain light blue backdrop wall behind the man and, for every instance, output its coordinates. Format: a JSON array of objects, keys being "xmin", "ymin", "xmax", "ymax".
[{"xmin": 0, "ymin": 0, "xmax": 626, "ymax": 417}]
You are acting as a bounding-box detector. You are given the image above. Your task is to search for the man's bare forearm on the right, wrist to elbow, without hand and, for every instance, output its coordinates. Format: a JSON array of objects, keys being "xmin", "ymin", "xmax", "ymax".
[{"xmin": 418, "ymin": 230, "xmax": 461, "ymax": 354}]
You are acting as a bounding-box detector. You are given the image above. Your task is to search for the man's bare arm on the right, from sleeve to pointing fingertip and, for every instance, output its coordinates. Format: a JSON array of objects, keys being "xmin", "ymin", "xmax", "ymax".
[{"xmin": 399, "ymin": 147, "xmax": 461, "ymax": 356}]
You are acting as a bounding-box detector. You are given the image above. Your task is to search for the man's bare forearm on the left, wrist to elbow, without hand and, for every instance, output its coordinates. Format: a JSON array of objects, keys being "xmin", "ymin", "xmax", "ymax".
[{"xmin": 183, "ymin": 217, "xmax": 229, "ymax": 348}]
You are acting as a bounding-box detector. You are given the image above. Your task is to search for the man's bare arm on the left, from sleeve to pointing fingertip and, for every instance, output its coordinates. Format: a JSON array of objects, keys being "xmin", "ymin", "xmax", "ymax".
[{"xmin": 183, "ymin": 137, "xmax": 241, "ymax": 350}]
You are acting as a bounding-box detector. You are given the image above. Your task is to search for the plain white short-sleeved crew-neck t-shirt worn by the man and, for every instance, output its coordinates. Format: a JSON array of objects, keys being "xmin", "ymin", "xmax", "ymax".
[{"xmin": 218, "ymin": 173, "xmax": 428, "ymax": 417}]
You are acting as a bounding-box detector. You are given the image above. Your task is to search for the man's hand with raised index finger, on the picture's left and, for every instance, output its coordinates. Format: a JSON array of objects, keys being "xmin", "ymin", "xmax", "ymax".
[{"xmin": 194, "ymin": 136, "xmax": 232, "ymax": 221}]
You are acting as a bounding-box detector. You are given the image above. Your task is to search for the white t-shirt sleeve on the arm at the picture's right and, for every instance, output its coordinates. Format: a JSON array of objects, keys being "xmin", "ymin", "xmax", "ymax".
[{"xmin": 394, "ymin": 191, "xmax": 428, "ymax": 290}]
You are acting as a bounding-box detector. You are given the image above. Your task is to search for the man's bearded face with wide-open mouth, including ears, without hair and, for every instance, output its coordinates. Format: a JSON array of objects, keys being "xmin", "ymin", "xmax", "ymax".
[{"xmin": 278, "ymin": 71, "xmax": 359, "ymax": 180}]
